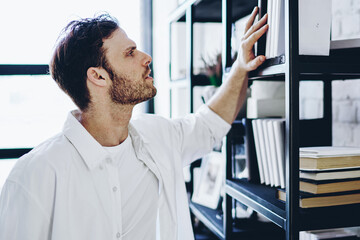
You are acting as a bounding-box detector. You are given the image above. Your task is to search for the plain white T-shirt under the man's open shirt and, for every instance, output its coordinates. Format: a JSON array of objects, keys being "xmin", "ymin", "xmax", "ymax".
[{"xmin": 104, "ymin": 136, "xmax": 159, "ymax": 240}]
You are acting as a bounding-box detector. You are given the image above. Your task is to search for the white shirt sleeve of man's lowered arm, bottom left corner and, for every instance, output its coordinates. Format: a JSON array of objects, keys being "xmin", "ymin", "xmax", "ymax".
[{"xmin": 0, "ymin": 180, "xmax": 51, "ymax": 240}]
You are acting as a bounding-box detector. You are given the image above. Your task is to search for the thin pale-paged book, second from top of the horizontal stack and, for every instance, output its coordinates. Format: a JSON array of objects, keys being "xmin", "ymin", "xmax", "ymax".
[{"xmin": 299, "ymin": 168, "xmax": 360, "ymax": 180}]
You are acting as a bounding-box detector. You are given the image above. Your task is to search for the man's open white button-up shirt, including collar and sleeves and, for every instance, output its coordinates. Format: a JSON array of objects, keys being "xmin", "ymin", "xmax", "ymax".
[{"xmin": 0, "ymin": 106, "xmax": 230, "ymax": 240}]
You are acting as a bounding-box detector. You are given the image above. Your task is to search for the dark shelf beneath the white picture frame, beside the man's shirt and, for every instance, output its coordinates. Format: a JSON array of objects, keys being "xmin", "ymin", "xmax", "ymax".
[{"xmin": 190, "ymin": 202, "xmax": 225, "ymax": 239}]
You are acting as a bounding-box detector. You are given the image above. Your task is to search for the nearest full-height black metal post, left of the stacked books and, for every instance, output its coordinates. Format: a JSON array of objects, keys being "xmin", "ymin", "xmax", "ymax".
[{"xmin": 285, "ymin": 0, "xmax": 300, "ymax": 240}]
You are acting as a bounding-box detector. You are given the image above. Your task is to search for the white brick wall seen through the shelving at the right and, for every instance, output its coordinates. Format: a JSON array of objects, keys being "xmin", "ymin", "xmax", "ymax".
[{"xmin": 300, "ymin": 0, "xmax": 360, "ymax": 146}]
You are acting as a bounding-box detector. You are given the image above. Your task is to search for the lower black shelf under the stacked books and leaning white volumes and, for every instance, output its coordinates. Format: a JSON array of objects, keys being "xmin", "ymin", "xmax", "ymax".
[{"xmin": 225, "ymin": 180, "xmax": 360, "ymax": 231}]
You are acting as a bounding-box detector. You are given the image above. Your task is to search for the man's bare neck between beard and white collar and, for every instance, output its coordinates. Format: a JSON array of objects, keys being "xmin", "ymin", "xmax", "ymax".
[{"xmin": 80, "ymin": 105, "xmax": 134, "ymax": 147}]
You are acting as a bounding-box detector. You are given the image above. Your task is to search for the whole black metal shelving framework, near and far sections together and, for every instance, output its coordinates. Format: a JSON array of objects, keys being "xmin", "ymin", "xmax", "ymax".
[{"xmin": 170, "ymin": 0, "xmax": 360, "ymax": 240}]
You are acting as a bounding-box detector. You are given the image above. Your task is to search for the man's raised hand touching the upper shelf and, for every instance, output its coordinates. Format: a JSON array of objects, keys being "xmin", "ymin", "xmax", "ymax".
[{"xmin": 233, "ymin": 7, "xmax": 268, "ymax": 72}]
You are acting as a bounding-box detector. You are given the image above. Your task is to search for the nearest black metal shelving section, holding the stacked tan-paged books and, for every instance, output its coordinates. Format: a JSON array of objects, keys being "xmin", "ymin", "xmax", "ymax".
[{"xmin": 223, "ymin": 0, "xmax": 360, "ymax": 240}]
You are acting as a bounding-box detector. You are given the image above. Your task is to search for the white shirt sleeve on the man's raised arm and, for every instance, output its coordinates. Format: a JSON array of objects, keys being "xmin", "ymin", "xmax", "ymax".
[{"xmin": 174, "ymin": 105, "xmax": 231, "ymax": 166}]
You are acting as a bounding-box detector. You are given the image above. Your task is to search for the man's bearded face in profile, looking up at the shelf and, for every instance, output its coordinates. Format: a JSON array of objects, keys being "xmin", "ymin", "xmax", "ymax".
[{"xmin": 104, "ymin": 29, "xmax": 156, "ymax": 104}]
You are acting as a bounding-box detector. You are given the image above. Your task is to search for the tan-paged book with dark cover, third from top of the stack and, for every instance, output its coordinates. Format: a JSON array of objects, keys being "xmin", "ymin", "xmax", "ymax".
[{"xmin": 300, "ymin": 178, "xmax": 360, "ymax": 194}]
